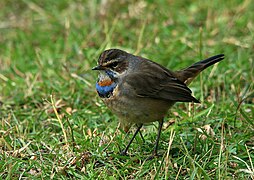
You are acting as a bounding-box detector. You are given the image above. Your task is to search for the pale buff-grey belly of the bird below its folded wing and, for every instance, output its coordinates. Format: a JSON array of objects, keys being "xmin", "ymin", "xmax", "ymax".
[{"xmin": 103, "ymin": 87, "xmax": 174, "ymax": 124}]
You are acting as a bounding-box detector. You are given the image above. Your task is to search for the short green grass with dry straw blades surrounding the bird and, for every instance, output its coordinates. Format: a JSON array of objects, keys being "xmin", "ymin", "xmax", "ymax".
[{"xmin": 0, "ymin": 0, "xmax": 254, "ymax": 179}]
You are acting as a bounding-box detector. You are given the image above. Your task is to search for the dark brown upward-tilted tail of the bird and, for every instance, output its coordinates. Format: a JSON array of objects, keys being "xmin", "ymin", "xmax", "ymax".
[{"xmin": 176, "ymin": 54, "xmax": 224, "ymax": 84}]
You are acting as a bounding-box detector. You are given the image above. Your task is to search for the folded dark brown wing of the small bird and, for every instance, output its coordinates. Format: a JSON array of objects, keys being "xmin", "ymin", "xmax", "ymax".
[{"xmin": 123, "ymin": 60, "xmax": 199, "ymax": 102}]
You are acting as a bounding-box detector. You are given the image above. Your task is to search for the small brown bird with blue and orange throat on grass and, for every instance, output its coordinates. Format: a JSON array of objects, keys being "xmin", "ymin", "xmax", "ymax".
[{"xmin": 92, "ymin": 49, "xmax": 224, "ymax": 156}]
